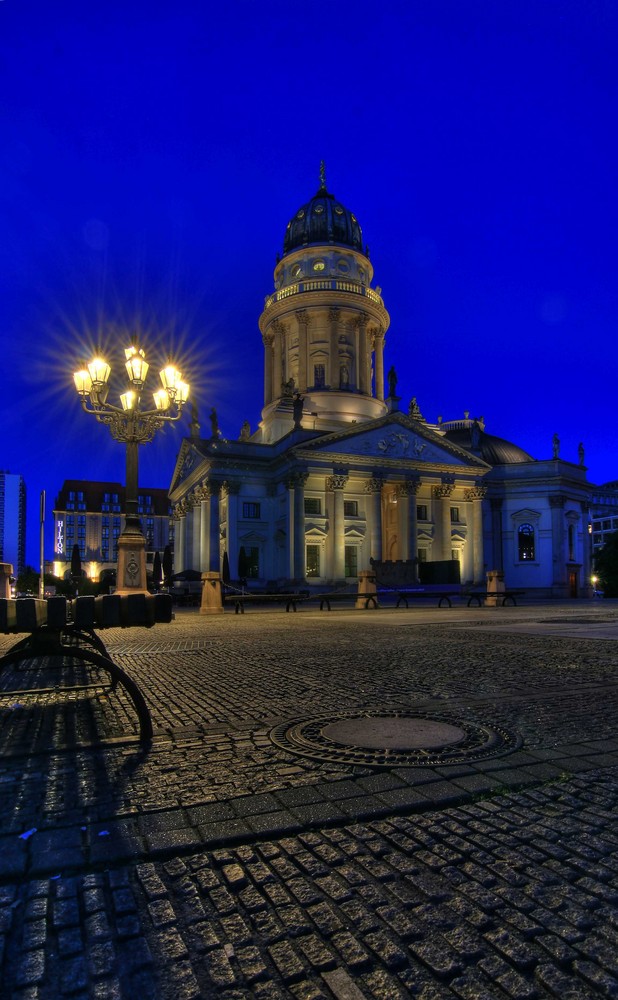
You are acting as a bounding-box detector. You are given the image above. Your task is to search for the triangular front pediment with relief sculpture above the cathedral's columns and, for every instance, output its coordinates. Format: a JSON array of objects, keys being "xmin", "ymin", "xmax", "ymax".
[{"xmin": 295, "ymin": 413, "xmax": 489, "ymax": 470}]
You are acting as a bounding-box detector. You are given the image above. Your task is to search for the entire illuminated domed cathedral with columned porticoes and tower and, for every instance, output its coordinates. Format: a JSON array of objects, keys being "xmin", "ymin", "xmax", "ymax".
[{"xmin": 170, "ymin": 165, "xmax": 590, "ymax": 596}]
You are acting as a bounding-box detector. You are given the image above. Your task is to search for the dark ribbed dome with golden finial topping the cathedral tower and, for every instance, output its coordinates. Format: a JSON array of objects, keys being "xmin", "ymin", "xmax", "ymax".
[{"xmin": 283, "ymin": 164, "xmax": 363, "ymax": 254}]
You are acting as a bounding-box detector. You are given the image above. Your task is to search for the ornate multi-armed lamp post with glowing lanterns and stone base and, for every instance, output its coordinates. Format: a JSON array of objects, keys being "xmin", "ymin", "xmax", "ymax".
[{"xmin": 73, "ymin": 345, "xmax": 189, "ymax": 594}]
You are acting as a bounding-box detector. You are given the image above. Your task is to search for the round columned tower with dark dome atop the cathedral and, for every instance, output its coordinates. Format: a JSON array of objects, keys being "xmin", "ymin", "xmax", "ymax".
[{"xmin": 260, "ymin": 164, "xmax": 389, "ymax": 443}]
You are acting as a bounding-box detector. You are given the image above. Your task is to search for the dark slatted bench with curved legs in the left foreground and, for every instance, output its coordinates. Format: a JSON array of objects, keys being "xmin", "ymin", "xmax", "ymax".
[{"xmin": 0, "ymin": 594, "xmax": 173, "ymax": 742}]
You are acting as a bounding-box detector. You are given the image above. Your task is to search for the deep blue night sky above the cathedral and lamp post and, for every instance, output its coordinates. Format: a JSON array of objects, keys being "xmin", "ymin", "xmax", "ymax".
[{"xmin": 0, "ymin": 0, "xmax": 618, "ymax": 564}]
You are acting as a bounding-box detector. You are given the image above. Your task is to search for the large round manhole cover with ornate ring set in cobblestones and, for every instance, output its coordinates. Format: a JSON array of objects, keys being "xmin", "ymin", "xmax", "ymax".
[{"xmin": 270, "ymin": 711, "xmax": 521, "ymax": 767}]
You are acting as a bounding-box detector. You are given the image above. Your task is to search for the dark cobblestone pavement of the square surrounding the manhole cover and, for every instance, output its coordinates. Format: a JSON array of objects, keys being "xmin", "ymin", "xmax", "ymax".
[{"xmin": 0, "ymin": 602, "xmax": 618, "ymax": 1000}]
